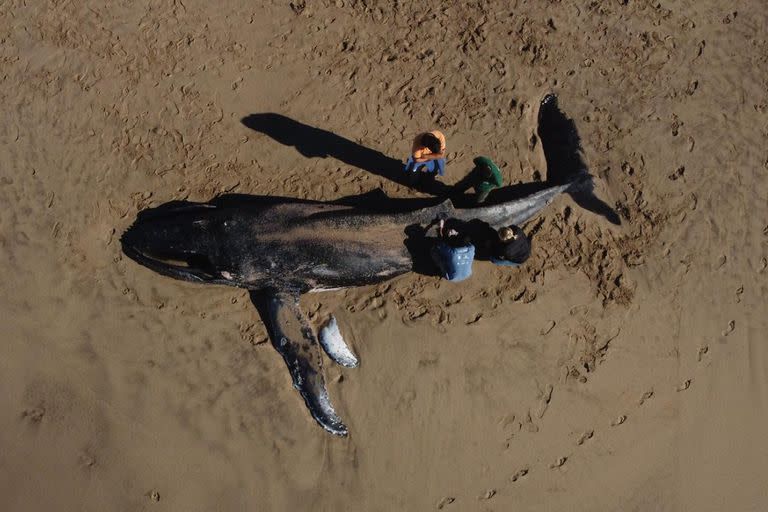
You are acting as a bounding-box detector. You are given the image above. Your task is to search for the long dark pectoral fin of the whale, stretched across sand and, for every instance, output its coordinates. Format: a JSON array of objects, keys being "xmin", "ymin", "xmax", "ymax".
[{"xmin": 251, "ymin": 293, "xmax": 347, "ymax": 436}]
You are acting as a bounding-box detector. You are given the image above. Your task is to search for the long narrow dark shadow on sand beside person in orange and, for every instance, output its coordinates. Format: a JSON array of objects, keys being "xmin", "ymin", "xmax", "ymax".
[{"xmin": 241, "ymin": 112, "xmax": 450, "ymax": 195}]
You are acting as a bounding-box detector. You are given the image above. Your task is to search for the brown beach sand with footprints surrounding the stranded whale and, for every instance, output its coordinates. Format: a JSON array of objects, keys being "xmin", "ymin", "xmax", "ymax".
[{"xmin": 0, "ymin": 0, "xmax": 768, "ymax": 511}]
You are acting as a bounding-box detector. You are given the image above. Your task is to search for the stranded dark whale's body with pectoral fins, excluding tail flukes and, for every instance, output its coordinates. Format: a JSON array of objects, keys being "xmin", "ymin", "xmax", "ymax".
[{"xmin": 121, "ymin": 182, "xmax": 574, "ymax": 436}]
